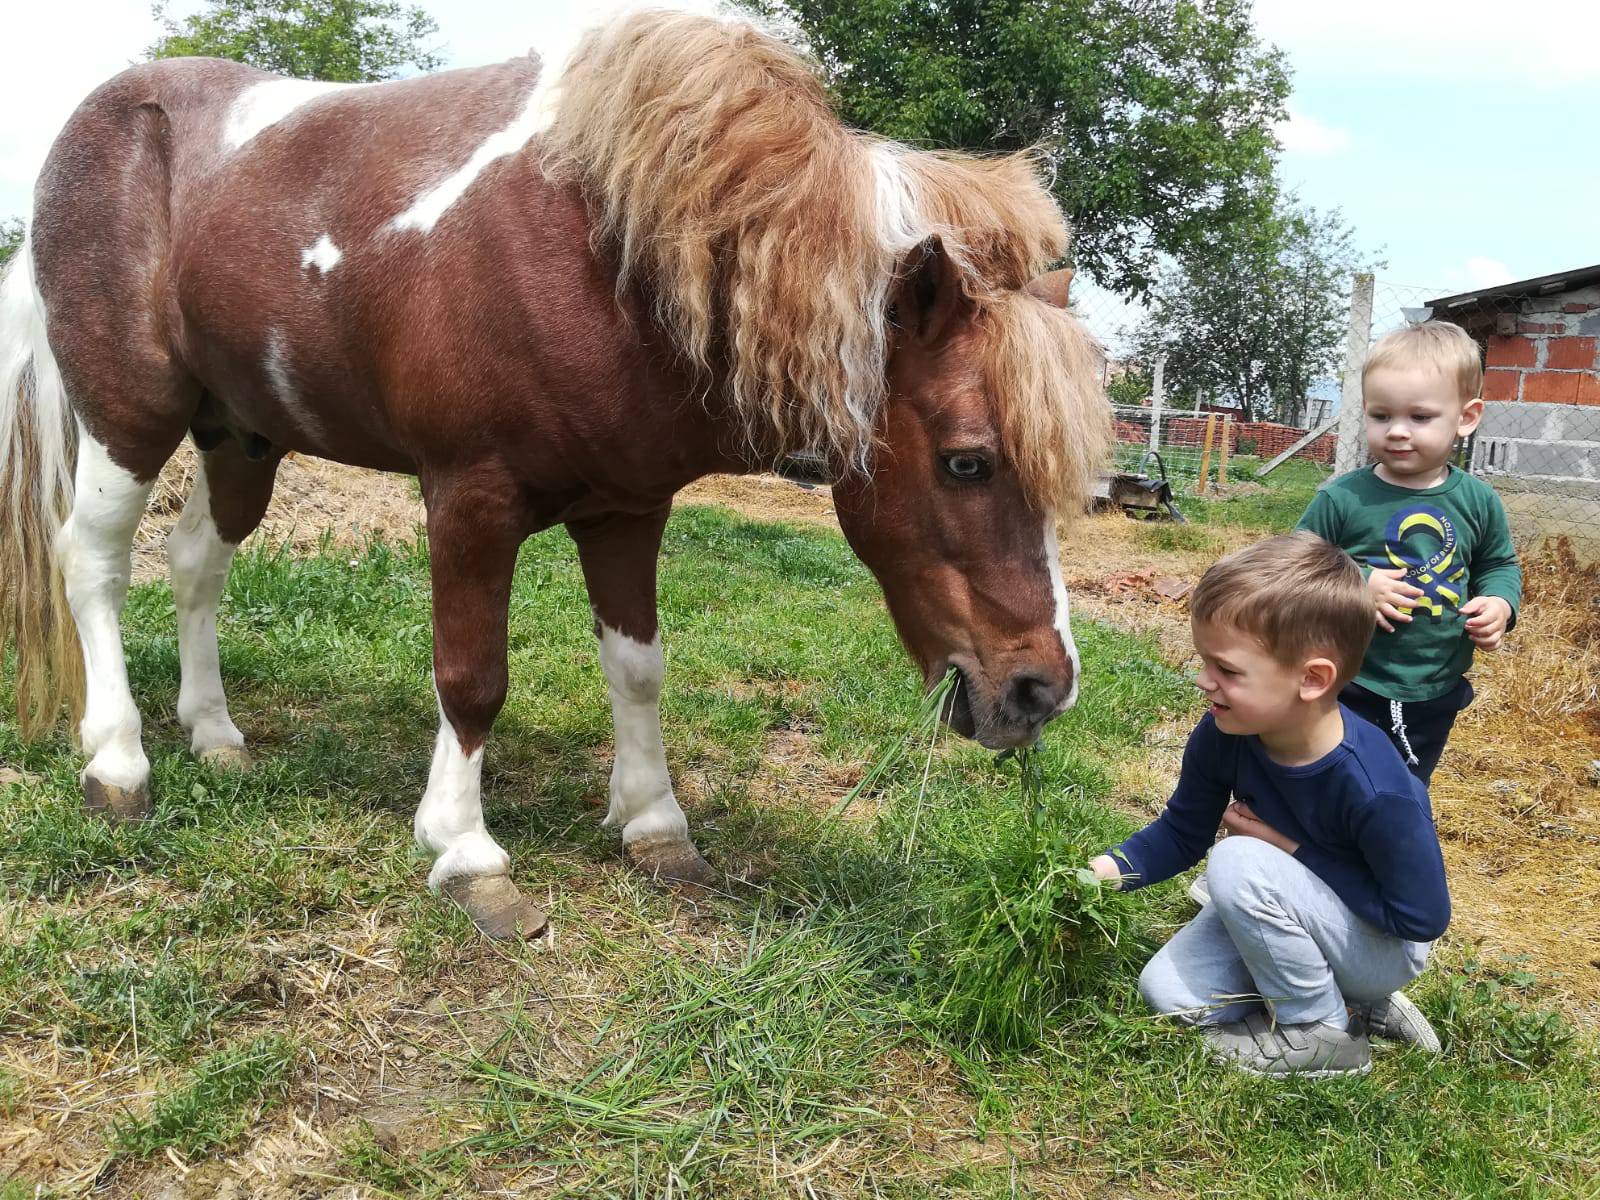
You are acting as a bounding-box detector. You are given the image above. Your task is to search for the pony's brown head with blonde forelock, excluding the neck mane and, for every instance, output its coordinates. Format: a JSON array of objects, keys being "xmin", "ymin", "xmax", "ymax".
[{"xmin": 834, "ymin": 249, "xmax": 1104, "ymax": 749}]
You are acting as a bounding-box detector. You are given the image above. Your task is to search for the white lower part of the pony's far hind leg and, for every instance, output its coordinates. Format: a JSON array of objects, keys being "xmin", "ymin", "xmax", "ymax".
[{"xmin": 166, "ymin": 470, "xmax": 245, "ymax": 755}]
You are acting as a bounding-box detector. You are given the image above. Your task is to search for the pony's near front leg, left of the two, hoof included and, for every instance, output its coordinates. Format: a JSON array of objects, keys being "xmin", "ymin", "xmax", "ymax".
[{"xmin": 413, "ymin": 472, "xmax": 546, "ymax": 938}]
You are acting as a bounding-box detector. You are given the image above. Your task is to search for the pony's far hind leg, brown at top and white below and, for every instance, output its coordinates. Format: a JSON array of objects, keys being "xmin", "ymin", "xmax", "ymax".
[{"xmin": 166, "ymin": 440, "xmax": 280, "ymax": 770}]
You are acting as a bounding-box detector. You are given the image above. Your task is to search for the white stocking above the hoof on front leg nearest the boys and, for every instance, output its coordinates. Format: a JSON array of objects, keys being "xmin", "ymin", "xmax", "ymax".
[{"xmin": 600, "ymin": 626, "xmax": 690, "ymax": 843}]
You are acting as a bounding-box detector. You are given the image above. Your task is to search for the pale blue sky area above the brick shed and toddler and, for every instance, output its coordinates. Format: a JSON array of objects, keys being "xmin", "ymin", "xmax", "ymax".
[{"xmin": 1256, "ymin": 0, "xmax": 1600, "ymax": 291}]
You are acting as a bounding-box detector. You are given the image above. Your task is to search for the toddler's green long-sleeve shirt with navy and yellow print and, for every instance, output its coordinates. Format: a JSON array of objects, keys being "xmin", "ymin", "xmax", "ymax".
[{"xmin": 1299, "ymin": 467, "xmax": 1522, "ymax": 702}]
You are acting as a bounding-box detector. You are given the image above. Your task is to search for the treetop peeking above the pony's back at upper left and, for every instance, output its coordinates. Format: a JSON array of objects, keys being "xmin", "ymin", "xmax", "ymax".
[{"xmin": 146, "ymin": 0, "xmax": 443, "ymax": 83}]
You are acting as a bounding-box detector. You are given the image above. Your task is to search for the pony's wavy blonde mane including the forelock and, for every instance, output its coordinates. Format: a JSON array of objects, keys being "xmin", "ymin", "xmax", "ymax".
[{"xmin": 544, "ymin": 11, "xmax": 1106, "ymax": 515}]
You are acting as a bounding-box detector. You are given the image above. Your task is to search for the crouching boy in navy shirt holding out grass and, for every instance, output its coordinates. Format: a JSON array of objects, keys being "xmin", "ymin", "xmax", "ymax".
[{"xmin": 1090, "ymin": 531, "xmax": 1450, "ymax": 1077}]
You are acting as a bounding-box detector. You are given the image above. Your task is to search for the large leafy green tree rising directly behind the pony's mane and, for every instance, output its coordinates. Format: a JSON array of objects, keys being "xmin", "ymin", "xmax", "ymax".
[{"xmin": 742, "ymin": 0, "xmax": 1290, "ymax": 293}]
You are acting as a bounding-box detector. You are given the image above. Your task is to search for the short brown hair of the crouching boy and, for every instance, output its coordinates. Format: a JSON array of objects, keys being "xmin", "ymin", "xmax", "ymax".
[{"xmin": 1189, "ymin": 530, "xmax": 1378, "ymax": 686}]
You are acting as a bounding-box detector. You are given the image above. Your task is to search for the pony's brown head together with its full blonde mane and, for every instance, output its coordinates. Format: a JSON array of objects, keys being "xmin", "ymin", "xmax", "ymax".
[{"xmin": 542, "ymin": 11, "xmax": 1110, "ymax": 747}]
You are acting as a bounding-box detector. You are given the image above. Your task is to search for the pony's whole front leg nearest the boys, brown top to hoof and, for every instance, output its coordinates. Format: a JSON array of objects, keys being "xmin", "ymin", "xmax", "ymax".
[{"xmin": 566, "ymin": 507, "xmax": 715, "ymax": 886}]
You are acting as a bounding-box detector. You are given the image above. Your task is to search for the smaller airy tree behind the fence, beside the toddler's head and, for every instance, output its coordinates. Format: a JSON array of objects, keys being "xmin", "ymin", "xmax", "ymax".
[{"xmin": 1133, "ymin": 197, "xmax": 1382, "ymax": 424}]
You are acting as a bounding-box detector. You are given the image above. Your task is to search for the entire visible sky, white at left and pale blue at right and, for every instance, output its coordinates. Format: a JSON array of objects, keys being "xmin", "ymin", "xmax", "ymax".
[{"xmin": 0, "ymin": 0, "xmax": 1600, "ymax": 310}]
